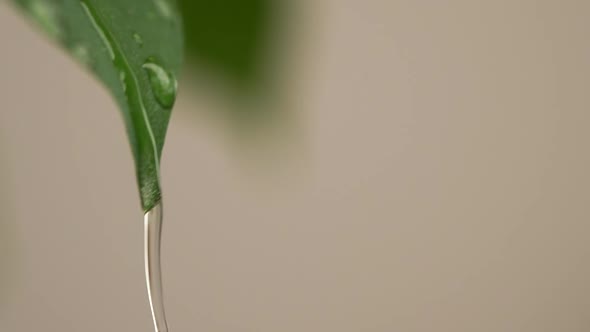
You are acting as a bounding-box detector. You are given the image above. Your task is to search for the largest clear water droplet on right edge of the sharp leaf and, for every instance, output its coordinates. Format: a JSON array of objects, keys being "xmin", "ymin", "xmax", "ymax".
[{"xmin": 142, "ymin": 57, "xmax": 178, "ymax": 109}]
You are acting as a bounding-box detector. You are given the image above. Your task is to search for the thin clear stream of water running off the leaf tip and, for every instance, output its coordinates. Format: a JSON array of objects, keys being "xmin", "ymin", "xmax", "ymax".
[{"xmin": 144, "ymin": 202, "xmax": 168, "ymax": 332}]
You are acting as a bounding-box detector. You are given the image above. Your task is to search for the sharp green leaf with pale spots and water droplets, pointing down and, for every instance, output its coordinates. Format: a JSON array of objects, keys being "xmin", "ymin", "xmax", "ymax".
[{"xmin": 13, "ymin": 0, "xmax": 183, "ymax": 211}]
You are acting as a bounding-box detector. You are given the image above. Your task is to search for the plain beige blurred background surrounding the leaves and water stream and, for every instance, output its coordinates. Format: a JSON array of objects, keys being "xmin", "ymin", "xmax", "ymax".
[{"xmin": 0, "ymin": 0, "xmax": 590, "ymax": 332}]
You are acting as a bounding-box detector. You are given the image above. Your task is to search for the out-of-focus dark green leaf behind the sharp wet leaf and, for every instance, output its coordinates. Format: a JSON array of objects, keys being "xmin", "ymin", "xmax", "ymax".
[{"xmin": 179, "ymin": 0, "xmax": 278, "ymax": 89}]
